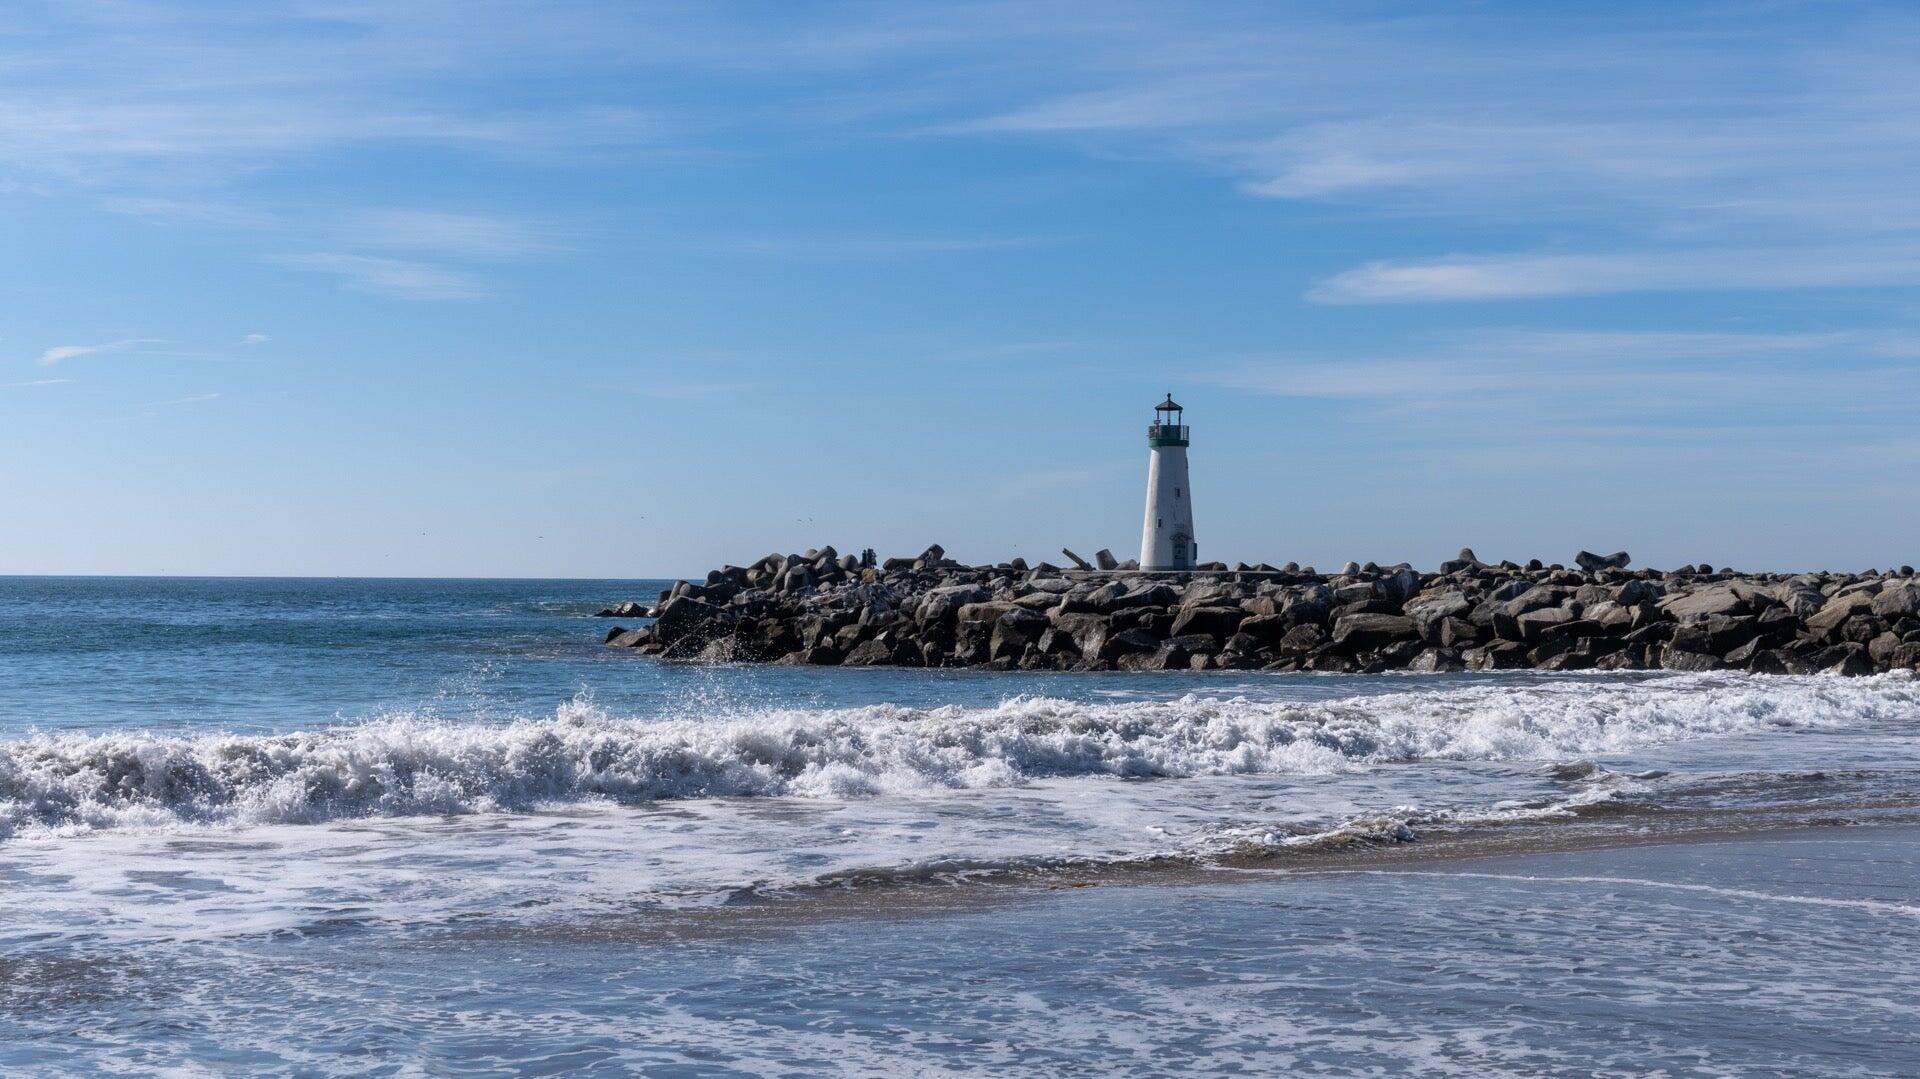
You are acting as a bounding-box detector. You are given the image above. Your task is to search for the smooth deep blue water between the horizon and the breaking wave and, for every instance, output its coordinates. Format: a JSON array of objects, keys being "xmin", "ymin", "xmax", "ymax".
[{"xmin": 0, "ymin": 576, "xmax": 1367, "ymax": 733}]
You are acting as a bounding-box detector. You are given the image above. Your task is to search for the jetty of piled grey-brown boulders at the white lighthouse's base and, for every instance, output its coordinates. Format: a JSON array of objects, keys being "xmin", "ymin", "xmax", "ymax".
[{"xmin": 603, "ymin": 545, "xmax": 1920, "ymax": 674}]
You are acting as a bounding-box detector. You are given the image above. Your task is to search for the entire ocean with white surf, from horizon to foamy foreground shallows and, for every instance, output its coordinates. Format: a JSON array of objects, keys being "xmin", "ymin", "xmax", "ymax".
[{"xmin": 0, "ymin": 578, "xmax": 1920, "ymax": 1075}]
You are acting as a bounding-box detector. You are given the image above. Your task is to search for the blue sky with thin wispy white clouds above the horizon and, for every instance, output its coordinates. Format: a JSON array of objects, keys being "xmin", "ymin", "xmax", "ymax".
[{"xmin": 0, "ymin": 0, "xmax": 1920, "ymax": 576}]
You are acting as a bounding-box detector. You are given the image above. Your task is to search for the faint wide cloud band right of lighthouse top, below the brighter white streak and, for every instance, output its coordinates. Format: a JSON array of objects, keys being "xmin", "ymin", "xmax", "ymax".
[{"xmin": 1208, "ymin": 330, "xmax": 1920, "ymax": 437}]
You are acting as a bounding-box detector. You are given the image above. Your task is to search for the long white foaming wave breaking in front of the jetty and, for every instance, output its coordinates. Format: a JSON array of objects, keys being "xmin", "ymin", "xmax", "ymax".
[{"xmin": 0, "ymin": 676, "xmax": 1920, "ymax": 837}]
